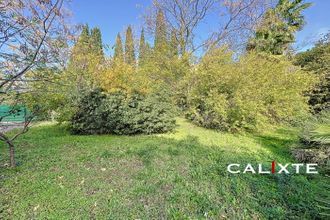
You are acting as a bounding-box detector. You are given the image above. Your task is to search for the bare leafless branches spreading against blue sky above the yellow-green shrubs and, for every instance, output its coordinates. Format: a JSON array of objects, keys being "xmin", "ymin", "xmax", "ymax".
[{"xmin": 145, "ymin": 0, "xmax": 273, "ymax": 56}]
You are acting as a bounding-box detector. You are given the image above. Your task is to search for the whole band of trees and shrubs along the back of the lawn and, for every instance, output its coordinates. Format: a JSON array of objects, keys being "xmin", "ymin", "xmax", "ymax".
[{"xmin": 22, "ymin": 0, "xmax": 329, "ymax": 139}]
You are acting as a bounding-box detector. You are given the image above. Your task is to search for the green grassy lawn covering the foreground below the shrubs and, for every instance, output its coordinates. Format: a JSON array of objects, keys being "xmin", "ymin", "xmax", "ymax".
[{"xmin": 0, "ymin": 119, "xmax": 325, "ymax": 219}]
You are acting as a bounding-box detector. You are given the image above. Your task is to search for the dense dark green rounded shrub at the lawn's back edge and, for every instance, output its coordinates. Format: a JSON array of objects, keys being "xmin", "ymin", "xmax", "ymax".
[{"xmin": 71, "ymin": 89, "xmax": 175, "ymax": 135}]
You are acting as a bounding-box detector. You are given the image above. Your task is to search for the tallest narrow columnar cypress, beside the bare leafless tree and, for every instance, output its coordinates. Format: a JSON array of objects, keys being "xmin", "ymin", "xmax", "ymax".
[{"xmin": 154, "ymin": 10, "xmax": 168, "ymax": 53}]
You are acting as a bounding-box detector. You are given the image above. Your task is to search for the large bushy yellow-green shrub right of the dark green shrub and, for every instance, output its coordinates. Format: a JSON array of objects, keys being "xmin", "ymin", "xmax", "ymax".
[{"xmin": 186, "ymin": 48, "xmax": 314, "ymax": 131}]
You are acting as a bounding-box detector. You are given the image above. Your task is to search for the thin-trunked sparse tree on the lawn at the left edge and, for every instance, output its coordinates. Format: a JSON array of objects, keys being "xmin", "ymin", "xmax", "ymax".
[{"xmin": 0, "ymin": 0, "xmax": 70, "ymax": 167}]
